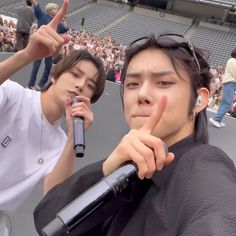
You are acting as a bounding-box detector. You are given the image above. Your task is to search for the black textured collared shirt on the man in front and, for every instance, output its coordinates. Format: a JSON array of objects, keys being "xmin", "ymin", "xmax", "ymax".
[{"xmin": 34, "ymin": 136, "xmax": 236, "ymax": 236}]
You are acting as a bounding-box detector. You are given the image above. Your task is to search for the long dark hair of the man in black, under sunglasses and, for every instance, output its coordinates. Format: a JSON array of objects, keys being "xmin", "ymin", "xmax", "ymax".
[{"xmin": 121, "ymin": 35, "xmax": 212, "ymax": 143}]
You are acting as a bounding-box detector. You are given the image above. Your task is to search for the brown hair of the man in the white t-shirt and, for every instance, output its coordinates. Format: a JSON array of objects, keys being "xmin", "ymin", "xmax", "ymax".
[{"xmin": 41, "ymin": 50, "xmax": 106, "ymax": 103}]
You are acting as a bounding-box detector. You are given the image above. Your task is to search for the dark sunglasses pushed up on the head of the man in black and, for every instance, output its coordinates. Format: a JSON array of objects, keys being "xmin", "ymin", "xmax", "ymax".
[{"xmin": 129, "ymin": 34, "xmax": 201, "ymax": 71}]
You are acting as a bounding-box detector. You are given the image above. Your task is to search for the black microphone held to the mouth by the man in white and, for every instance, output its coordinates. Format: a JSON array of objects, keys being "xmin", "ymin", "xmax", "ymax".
[{"xmin": 72, "ymin": 97, "xmax": 85, "ymax": 157}]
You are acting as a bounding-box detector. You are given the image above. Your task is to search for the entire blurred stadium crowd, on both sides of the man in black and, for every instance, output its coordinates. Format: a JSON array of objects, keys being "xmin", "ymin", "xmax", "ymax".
[{"xmin": 0, "ymin": 13, "xmax": 236, "ymax": 117}]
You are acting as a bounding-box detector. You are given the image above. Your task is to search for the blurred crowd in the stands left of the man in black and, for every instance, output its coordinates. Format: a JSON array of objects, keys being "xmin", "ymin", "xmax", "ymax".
[{"xmin": 0, "ymin": 16, "xmax": 126, "ymax": 82}]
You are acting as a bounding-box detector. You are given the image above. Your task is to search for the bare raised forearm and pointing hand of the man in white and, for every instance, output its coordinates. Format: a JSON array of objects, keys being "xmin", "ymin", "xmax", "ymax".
[{"xmin": 0, "ymin": 0, "xmax": 69, "ymax": 85}]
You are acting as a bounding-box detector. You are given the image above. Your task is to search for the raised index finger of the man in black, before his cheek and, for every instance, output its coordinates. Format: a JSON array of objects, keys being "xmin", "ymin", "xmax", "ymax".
[{"xmin": 141, "ymin": 96, "xmax": 167, "ymax": 134}]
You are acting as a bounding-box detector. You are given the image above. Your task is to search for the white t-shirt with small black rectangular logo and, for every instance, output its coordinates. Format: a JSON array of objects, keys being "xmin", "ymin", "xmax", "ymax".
[{"xmin": 0, "ymin": 80, "xmax": 66, "ymax": 211}]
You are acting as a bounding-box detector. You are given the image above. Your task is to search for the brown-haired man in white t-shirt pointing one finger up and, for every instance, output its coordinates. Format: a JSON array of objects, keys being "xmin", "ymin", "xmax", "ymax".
[{"xmin": 0, "ymin": 0, "xmax": 105, "ymax": 226}]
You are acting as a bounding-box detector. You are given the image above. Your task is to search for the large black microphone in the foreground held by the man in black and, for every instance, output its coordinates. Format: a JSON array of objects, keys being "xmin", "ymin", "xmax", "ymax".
[{"xmin": 41, "ymin": 162, "xmax": 137, "ymax": 236}]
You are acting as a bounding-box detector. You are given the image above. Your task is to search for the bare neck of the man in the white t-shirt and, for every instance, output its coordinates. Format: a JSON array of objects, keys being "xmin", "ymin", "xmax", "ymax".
[{"xmin": 40, "ymin": 86, "xmax": 65, "ymax": 124}]
